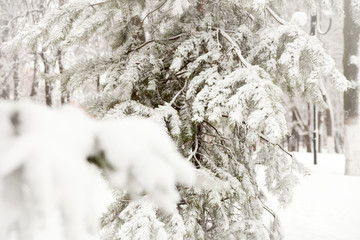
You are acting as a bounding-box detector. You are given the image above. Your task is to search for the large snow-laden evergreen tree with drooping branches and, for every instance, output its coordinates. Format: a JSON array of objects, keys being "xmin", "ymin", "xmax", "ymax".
[{"xmin": 3, "ymin": 0, "xmax": 348, "ymax": 240}]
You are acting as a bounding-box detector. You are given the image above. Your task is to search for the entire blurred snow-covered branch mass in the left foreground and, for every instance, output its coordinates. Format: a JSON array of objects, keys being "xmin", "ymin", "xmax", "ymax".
[{"xmin": 0, "ymin": 102, "xmax": 195, "ymax": 240}]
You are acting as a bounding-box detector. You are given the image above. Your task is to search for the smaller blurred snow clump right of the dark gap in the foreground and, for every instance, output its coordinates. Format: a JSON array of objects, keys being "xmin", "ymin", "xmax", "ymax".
[{"xmin": 98, "ymin": 117, "xmax": 195, "ymax": 212}]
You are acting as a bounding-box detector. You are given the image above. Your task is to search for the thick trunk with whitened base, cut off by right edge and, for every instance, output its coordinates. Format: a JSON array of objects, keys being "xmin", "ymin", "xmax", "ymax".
[{"xmin": 343, "ymin": 0, "xmax": 360, "ymax": 175}]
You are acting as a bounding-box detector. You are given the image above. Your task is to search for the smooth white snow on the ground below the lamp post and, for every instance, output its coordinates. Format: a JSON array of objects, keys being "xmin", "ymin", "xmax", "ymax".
[{"xmin": 277, "ymin": 153, "xmax": 360, "ymax": 240}]
